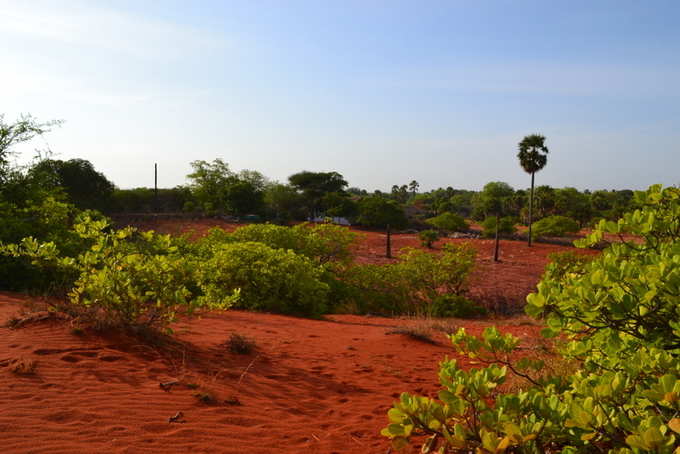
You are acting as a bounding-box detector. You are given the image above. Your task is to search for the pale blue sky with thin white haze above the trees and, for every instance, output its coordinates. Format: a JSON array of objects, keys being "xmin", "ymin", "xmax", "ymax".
[{"xmin": 0, "ymin": 0, "xmax": 680, "ymax": 190}]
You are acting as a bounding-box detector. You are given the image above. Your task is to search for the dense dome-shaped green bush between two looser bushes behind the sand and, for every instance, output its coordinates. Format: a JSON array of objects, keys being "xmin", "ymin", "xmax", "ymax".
[{"xmin": 198, "ymin": 241, "xmax": 328, "ymax": 316}]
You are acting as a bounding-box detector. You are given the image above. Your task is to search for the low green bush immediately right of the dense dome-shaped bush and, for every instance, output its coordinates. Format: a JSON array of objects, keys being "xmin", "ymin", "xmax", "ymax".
[{"xmin": 342, "ymin": 244, "xmax": 476, "ymax": 315}]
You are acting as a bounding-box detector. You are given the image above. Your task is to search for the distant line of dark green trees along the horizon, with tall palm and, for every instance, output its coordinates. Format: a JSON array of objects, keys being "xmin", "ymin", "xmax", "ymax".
[{"xmin": 0, "ymin": 116, "xmax": 634, "ymax": 238}]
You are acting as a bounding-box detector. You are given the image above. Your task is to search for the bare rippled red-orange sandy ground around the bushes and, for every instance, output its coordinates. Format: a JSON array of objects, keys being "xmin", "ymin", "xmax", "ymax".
[{"xmin": 0, "ymin": 222, "xmax": 596, "ymax": 454}]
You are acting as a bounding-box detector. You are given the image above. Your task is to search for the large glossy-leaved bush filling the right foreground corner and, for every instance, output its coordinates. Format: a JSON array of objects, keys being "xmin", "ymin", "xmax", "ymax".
[{"xmin": 382, "ymin": 186, "xmax": 680, "ymax": 454}]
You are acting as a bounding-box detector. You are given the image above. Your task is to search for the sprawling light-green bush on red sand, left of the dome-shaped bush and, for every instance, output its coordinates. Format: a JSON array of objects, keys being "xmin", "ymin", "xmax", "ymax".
[{"xmin": 0, "ymin": 219, "xmax": 238, "ymax": 327}]
